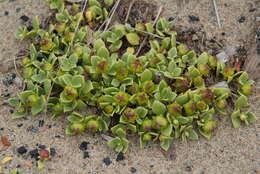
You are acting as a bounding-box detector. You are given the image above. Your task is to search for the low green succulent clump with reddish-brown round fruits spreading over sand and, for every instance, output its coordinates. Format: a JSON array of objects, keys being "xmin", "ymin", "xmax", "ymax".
[{"xmin": 9, "ymin": 0, "xmax": 256, "ymax": 152}]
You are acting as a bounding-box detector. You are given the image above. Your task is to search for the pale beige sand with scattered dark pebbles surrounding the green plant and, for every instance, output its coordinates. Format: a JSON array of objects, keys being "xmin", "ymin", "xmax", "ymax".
[{"xmin": 0, "ymin": 0, "xmax": 260, "ymax": 174}]
